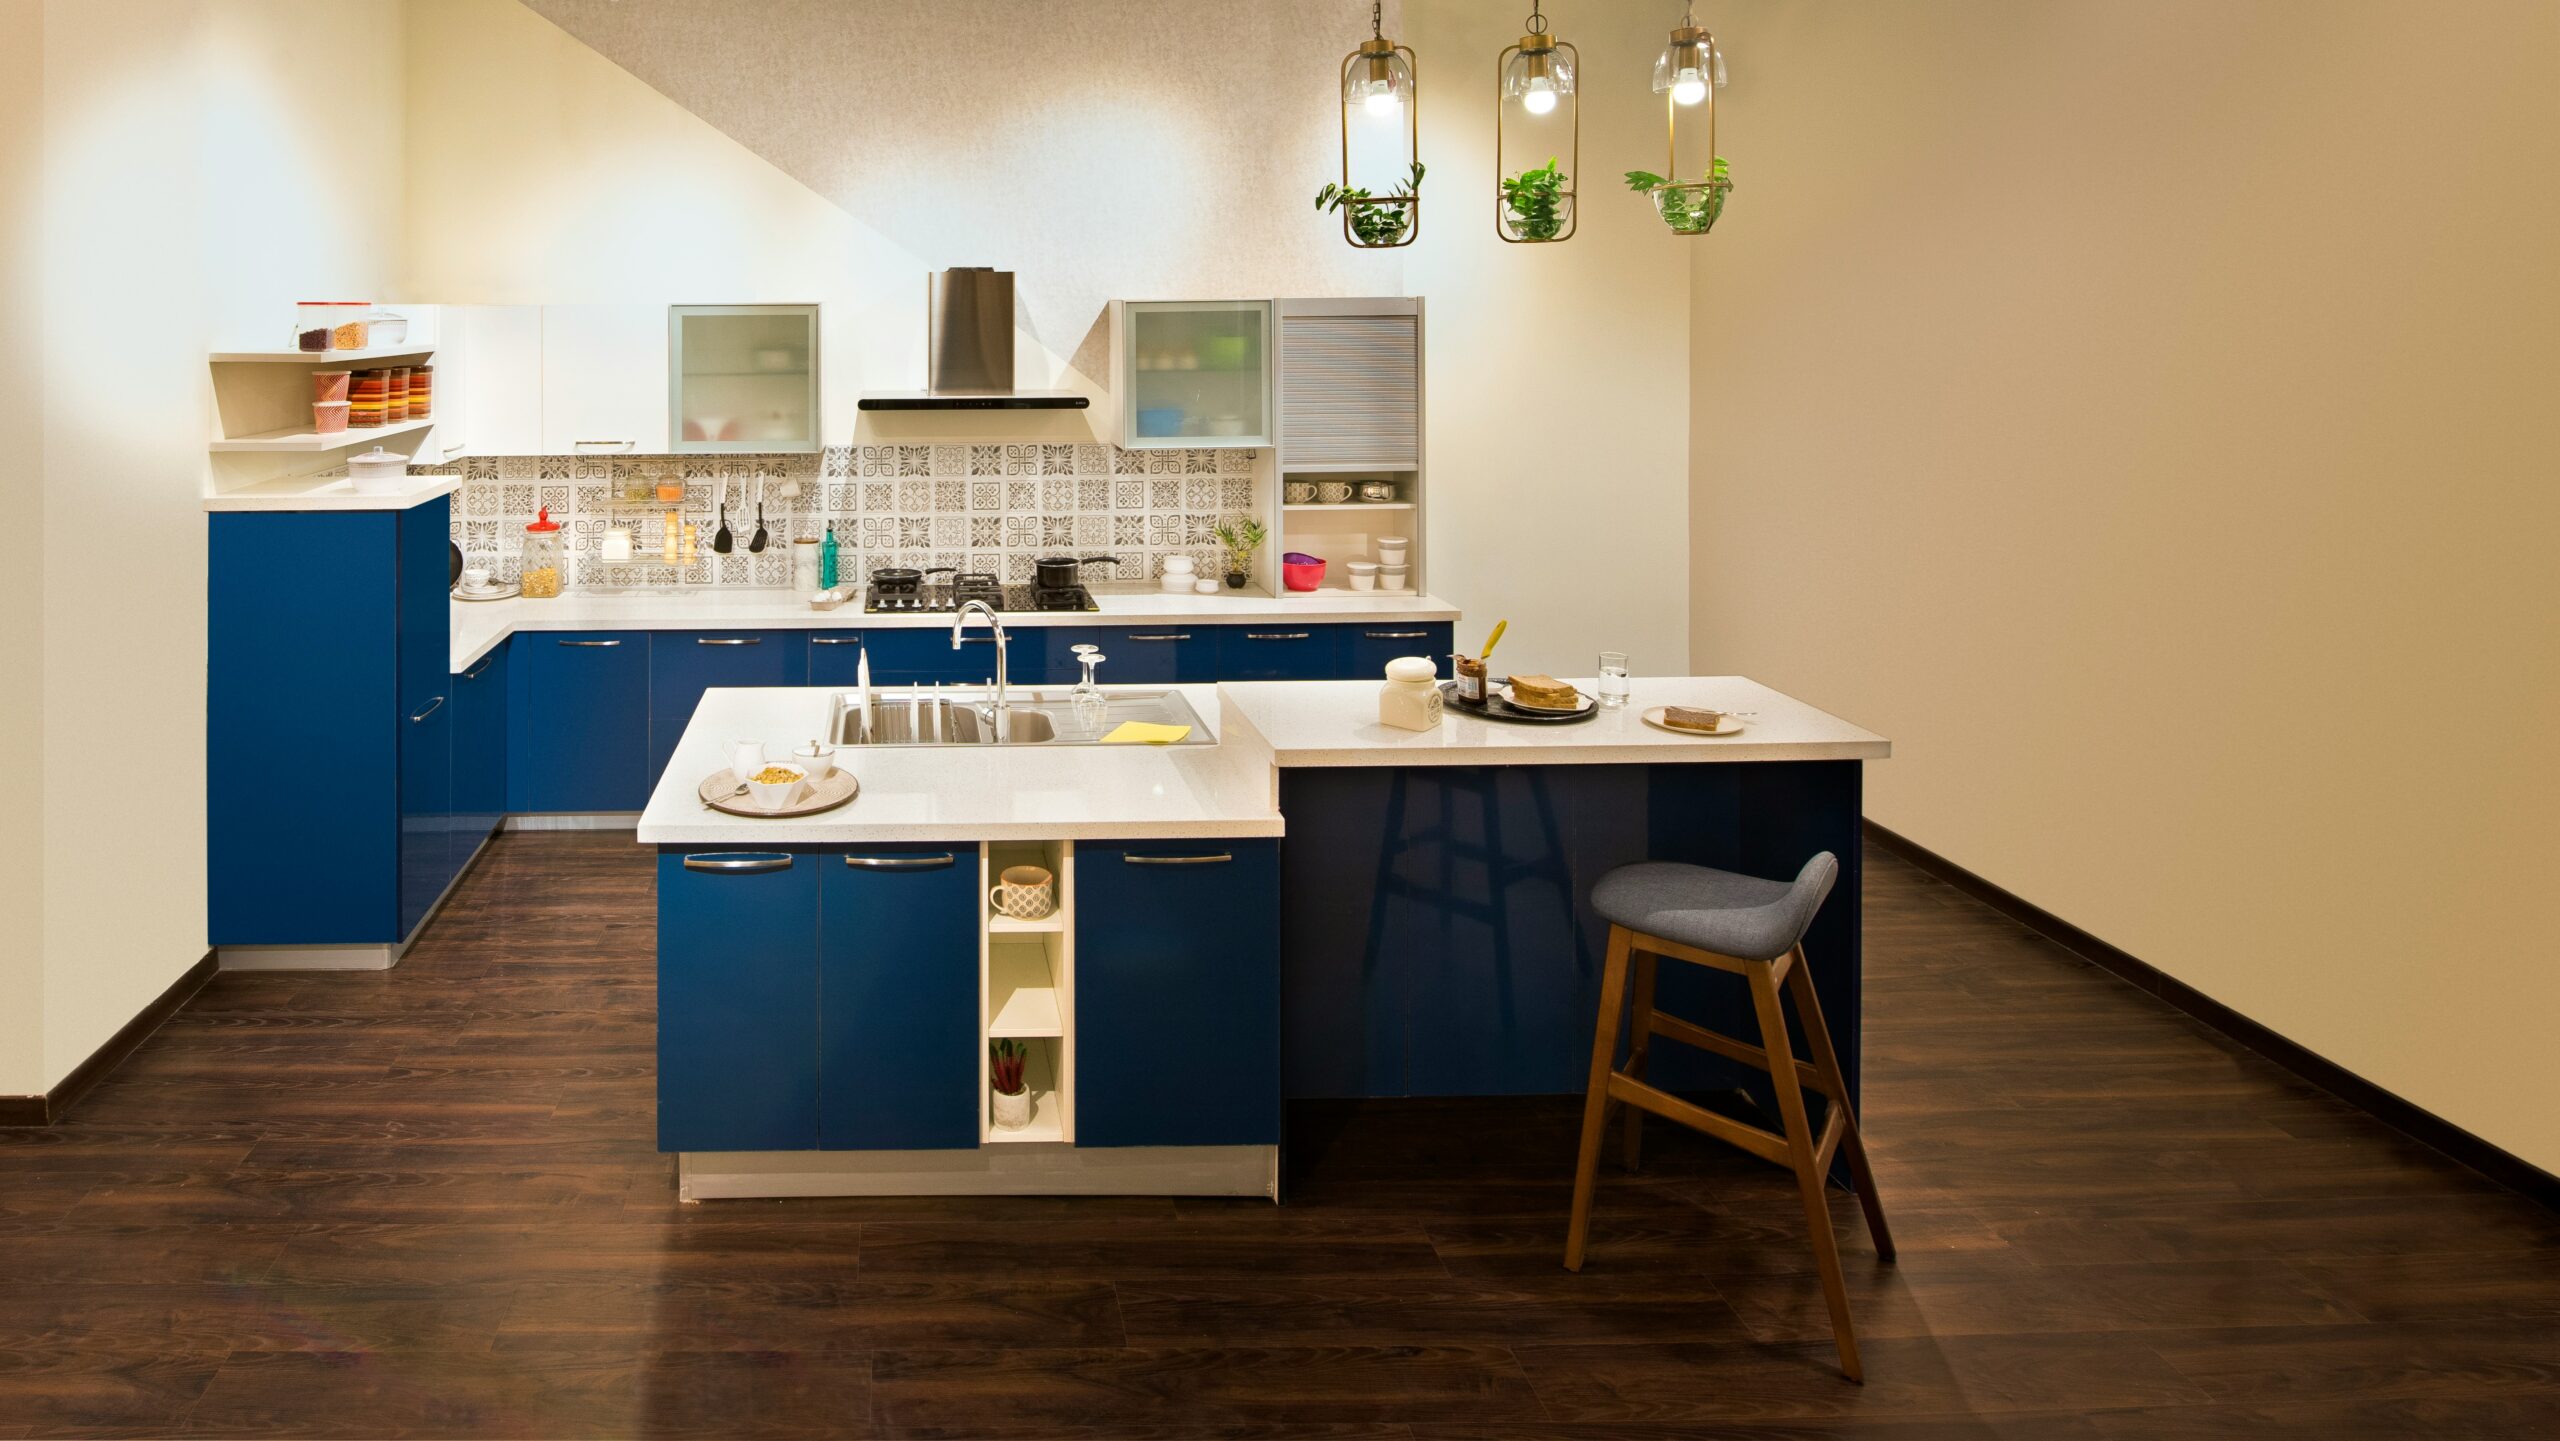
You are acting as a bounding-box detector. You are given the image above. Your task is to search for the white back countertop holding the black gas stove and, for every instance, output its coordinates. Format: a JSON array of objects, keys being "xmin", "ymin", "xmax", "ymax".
[{"xmin": 453, "ymin": 589, "xmax": 1459, "ymax": 673}]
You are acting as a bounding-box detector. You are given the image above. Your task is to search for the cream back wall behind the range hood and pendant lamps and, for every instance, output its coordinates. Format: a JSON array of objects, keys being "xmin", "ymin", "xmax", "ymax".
[{"xmin": 404, "ymin": 0, "xmax": 1687, "ymax": 673}]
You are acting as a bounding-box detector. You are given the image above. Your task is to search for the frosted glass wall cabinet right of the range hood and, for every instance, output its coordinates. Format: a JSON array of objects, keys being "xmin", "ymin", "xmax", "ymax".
[{"xmin": 1111, "ymin": 299, "xmax": 1272, "ymax": 450}]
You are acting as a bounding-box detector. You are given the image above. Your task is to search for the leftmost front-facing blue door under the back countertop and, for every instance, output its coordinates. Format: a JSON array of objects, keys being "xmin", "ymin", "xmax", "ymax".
[{"xmin": 507, "ymin": 630, "xmax": 650, "ymax": 811}]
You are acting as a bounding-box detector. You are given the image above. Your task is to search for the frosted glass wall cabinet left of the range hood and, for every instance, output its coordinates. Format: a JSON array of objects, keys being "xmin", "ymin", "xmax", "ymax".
[{"xmin": 666, "ymin": 305, "xmax": 819, "ymax": 453}]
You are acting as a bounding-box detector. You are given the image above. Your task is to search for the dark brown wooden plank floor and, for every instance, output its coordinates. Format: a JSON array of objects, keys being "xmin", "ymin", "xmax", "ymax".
[{"xmin": 0, "ymin": 834, "xmax": 2560, "ymax": 1441}]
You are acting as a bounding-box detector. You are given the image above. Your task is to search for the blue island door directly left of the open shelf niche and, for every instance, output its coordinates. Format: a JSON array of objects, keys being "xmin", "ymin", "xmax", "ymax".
[{"xmin": 817, "ymin": 845, "xmax": 980, "ymax": 1152}]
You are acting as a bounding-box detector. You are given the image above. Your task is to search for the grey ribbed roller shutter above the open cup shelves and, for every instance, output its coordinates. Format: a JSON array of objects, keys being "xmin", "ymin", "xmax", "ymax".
[{"xmin": 1280, "ymin": 299, "xmax": 1423, "ymax": 474}]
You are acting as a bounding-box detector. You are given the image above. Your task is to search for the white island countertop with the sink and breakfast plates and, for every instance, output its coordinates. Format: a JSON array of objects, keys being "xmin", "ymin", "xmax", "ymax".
[{"xmin": 640, "ymin": 675, "xmax": 1892, "ymax": 847}]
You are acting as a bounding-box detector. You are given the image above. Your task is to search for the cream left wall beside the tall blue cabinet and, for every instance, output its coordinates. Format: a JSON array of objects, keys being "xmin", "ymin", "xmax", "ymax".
[{"xmin": 0, "ymin": 0, "xmax": 402, "ymax": 1090}]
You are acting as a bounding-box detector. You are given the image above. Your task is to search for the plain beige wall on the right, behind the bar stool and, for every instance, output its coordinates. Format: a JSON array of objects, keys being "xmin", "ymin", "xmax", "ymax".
[{"xmin": 1692, "ymin": 0, "xmax": 2560, "ymax": 1170}]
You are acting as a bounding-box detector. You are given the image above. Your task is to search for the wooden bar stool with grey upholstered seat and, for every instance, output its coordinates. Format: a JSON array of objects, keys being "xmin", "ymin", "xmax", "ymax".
[{"xmin": 1564, "ymin": 850, "xmax": 1894, "ymax": 1382}]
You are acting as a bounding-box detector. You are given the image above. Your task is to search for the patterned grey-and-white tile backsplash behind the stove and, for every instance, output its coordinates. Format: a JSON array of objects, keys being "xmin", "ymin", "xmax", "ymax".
[{"xmin": 433, "ymin": 443, "xmax": 1262, "ymax": 589}]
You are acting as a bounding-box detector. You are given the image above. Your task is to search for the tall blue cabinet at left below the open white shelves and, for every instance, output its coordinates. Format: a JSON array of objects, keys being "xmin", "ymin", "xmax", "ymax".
[{"xmin": 205, "ymin": 497, "xmax": 463, "ymax": 947}]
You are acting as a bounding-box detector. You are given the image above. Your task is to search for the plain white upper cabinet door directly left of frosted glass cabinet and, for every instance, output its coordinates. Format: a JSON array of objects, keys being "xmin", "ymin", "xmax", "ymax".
[{"xmin": 543, "ymin": 305, "xmax": 668, "ymax": 456}]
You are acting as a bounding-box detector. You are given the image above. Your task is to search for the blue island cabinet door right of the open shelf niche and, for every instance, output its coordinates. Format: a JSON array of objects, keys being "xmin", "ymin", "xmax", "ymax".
[{"xmin": 1075, "ymin": 840, "xmax": 1280, "ymax": 1147}]
